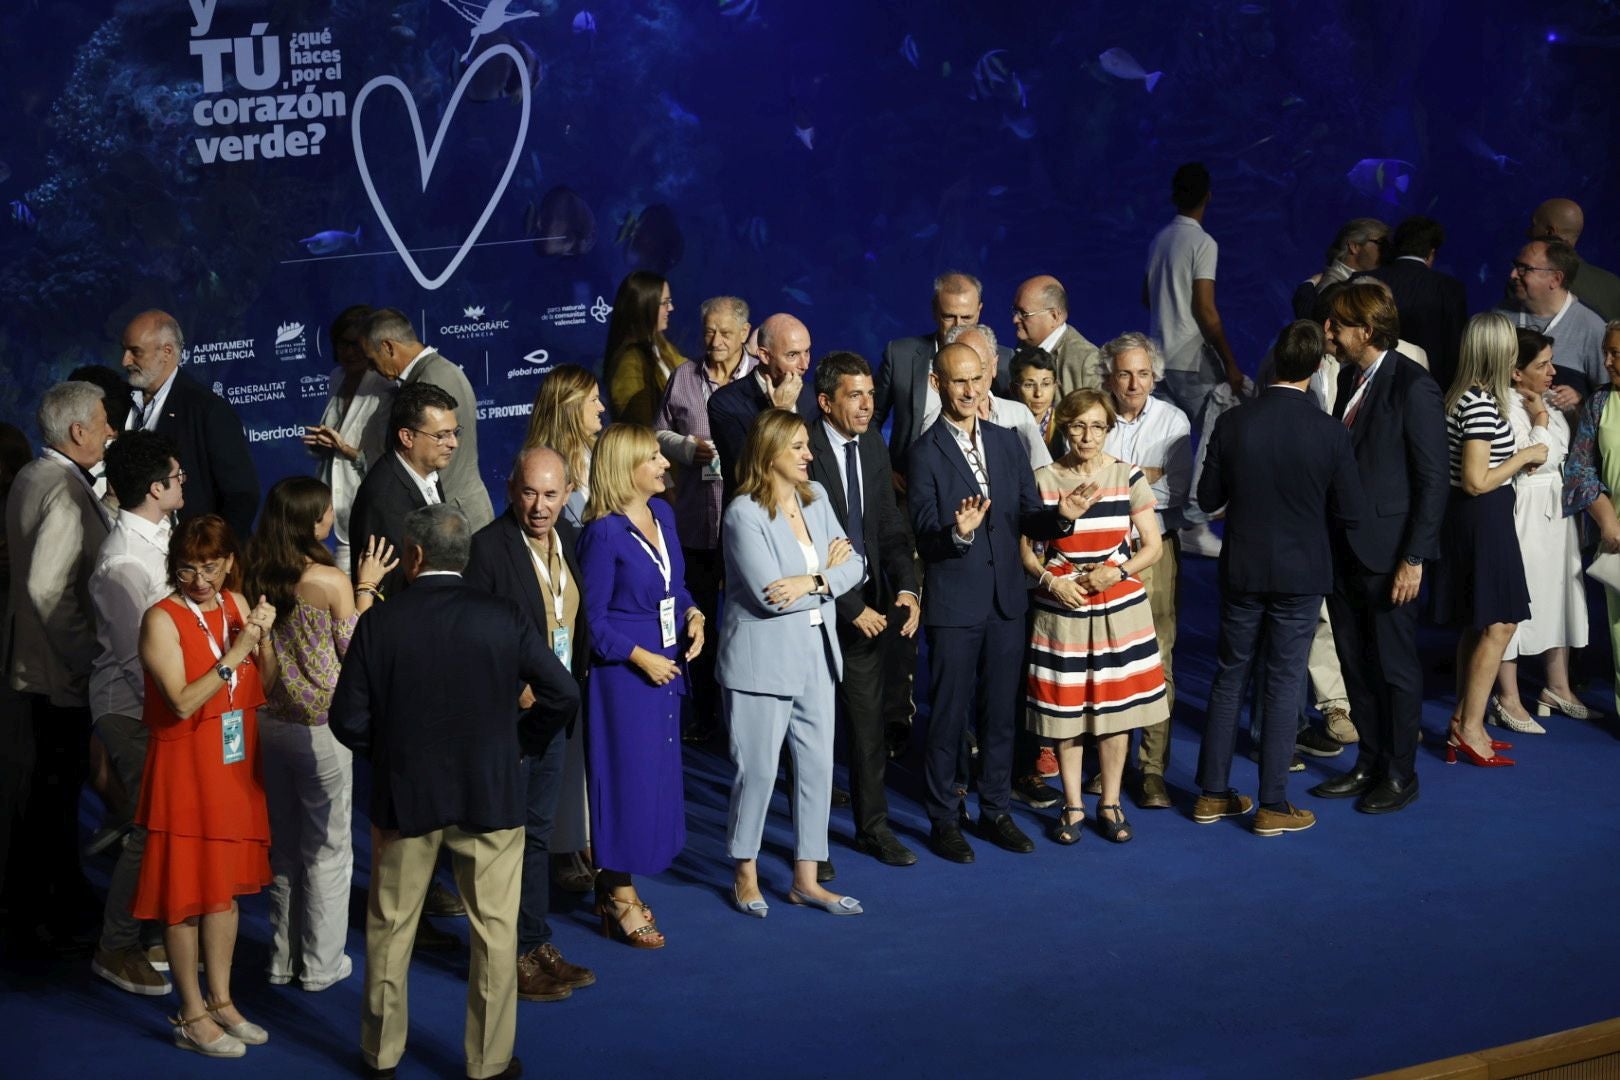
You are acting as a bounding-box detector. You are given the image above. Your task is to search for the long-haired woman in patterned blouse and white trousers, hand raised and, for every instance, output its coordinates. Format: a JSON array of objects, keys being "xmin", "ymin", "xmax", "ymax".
[{"xmin": 248, "ymin": 476, "xmax": 399, "ymax": 991}]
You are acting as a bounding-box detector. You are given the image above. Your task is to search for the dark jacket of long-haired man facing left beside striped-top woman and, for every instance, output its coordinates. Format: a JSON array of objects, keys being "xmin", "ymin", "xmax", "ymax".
[{"xmin": 1333, "ymin": 350, "xmax": 1452, "ymax": 573}]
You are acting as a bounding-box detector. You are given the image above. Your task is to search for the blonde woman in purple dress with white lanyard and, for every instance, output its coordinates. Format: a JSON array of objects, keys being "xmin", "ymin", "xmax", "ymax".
[{"xmin": 580, "ymin": 424, "xmax": 703, "ymax": 949}]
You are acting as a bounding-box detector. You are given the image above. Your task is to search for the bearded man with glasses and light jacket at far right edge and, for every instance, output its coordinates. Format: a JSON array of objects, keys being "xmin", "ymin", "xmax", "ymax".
[{"xmin": 1497, "ymin": 240, "xmax": 1609, "ymax": 410}]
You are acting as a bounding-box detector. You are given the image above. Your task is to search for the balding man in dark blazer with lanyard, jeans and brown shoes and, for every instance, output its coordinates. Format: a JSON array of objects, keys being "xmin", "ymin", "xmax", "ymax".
[{"xmin": 465, "ymin": 447, "xmax": 596, "ymax": 1001}]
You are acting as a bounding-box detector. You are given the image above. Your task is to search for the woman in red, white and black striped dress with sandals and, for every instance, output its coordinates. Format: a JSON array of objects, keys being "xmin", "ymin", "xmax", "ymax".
[{"xmin": 1024, "ymin": 390, "xmax": 1170, "ymax": 844}]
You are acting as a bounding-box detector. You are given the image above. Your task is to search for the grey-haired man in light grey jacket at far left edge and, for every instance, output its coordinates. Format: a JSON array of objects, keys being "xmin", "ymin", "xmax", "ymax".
[{"xmin": 0, "ymin": 382, "xmax": 113, "ymax": 938}]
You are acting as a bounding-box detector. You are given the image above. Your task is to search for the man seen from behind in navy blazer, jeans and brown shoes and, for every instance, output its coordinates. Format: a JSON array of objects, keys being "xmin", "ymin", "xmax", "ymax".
[{"xmin": 1192, "ymin": 319, "xmax": 1362, "ymax": 836}]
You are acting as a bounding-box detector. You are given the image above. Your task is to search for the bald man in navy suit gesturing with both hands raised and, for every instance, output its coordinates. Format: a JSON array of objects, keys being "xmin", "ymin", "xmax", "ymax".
[{"xmin": 907, "ymin": 345, "xmax": 1095, "ymax": 863}]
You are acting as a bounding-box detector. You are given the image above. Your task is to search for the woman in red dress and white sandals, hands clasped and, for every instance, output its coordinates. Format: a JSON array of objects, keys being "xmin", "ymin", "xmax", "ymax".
[{"xmin": 133, "ymin": 513, "xmax": 275, "ymax": 1057}]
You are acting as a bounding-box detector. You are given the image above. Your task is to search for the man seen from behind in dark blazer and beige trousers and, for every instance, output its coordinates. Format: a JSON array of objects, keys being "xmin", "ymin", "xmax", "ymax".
[{"xmin": 330, "ymin": 504, "xmax": 580, "ymax": 1075}]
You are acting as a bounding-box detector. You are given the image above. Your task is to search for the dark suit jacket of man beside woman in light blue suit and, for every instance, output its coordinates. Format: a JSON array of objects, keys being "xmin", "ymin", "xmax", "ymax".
[{"xmin": 810, "ymin": 418, "xmax": 917, "ymax": 623}]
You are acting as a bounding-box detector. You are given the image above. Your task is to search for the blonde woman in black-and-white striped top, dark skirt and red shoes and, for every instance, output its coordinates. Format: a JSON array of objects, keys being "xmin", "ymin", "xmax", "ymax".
[{"xmin": 1434, "ymin": 313, "xmax": 1547, "ymax": 766}]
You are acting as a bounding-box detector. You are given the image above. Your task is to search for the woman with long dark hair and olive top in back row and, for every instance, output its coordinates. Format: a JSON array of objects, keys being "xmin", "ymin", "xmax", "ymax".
[{"xmin": 603, "ymin": 270, "xmax": 687, "ymax": 427}]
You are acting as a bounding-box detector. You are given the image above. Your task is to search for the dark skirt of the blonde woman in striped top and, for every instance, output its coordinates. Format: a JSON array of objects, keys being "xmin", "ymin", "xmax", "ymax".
[{"xmin": 1434, "ymin": 484, "xmax": 1529, "ymax": 630}]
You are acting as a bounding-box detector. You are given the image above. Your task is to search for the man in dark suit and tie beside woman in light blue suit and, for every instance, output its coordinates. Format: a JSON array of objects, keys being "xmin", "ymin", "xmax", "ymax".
[{"xmin": 810, "ymin": 353, "xmax": 922, "ymax": 866}]
